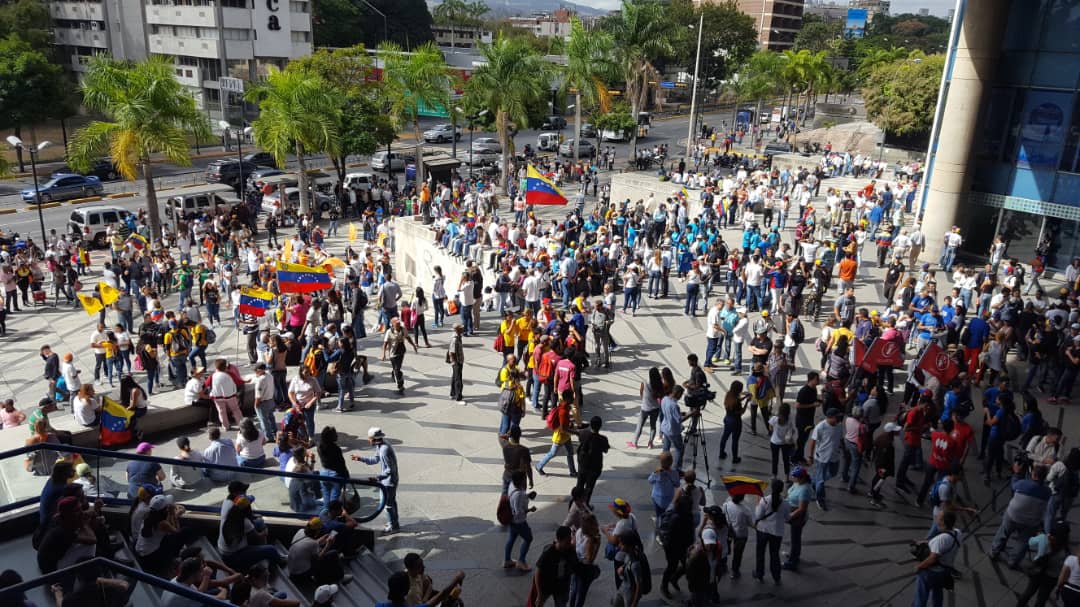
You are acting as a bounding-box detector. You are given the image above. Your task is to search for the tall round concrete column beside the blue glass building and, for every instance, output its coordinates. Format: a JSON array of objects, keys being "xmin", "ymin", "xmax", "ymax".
[{"xmin": 922, "ymin": 0, "xmax": 1018, "ymax": 261}]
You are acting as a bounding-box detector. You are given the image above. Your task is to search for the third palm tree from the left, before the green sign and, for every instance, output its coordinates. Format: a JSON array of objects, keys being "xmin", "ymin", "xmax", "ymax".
[{"xmin": 379, "ymin": 42, "xmax": 450, "ymax": 184}]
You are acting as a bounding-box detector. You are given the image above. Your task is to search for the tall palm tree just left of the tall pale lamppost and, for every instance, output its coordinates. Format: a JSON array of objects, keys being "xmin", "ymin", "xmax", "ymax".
[{"xmin": 610, "ymin": 0, "xmax": 675, "ymax": 158}]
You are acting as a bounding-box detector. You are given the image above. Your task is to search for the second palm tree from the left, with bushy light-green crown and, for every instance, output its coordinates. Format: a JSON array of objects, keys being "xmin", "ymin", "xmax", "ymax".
[{"xmin": 244, "ymin": 67, "xmax": 341, "ymax": 214}]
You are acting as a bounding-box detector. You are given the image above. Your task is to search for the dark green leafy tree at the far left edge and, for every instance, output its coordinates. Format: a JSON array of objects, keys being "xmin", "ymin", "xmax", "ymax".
[{"xmin": 0, "ymin": 33, "xmax": 68, "ymax": 172}]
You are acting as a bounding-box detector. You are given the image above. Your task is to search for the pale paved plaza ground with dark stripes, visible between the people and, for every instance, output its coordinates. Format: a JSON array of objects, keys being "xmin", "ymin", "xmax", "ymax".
[{"xmin": 0, "ymin": 171, "xmax": 1080, "ymax": 607}]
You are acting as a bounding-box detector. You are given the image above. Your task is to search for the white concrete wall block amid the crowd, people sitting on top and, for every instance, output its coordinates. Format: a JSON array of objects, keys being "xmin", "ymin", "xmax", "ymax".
[{"xmin": 394, "ymin": 217, "xmax": 495, "ymax": 298}]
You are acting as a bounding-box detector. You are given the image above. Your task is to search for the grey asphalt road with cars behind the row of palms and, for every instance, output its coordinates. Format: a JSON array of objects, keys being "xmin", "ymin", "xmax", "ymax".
[{"xmin": 0, "ymin": 112, "xmax": 743, "ymax": 237}]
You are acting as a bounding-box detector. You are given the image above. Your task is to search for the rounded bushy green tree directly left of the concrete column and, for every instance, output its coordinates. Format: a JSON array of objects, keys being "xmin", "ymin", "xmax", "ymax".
[{"xmin": 862, "ymin": 55, "xmax": 945, "ymax": 137}]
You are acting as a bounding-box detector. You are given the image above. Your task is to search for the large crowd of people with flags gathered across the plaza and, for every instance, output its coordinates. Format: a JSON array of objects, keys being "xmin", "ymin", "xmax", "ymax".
[{"xmin": 0, "ymin": 134, "xmax": 1080, "ymax": 607}]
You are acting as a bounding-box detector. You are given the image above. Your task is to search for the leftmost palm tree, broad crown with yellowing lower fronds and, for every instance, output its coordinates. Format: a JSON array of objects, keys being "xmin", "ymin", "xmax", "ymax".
[{"xmin": 68, "ymin": 55, "xmax": 211, "ymax": 240}]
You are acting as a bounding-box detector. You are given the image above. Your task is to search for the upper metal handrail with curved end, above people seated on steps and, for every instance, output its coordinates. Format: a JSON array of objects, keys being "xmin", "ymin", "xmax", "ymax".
[{"xmin": 0, "ymin": 443, "xmax": 387, "ymax": 523}]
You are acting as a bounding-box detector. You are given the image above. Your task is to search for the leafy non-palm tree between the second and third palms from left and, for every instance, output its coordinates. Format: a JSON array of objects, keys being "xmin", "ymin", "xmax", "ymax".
[{"xmin": 288, "ymin": 46, "xmax": 397, "ymax": 180}]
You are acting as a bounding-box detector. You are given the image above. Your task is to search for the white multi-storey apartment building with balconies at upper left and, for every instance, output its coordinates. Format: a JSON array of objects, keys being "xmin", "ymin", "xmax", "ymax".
[{"xmin": 49, "ymin": 0, "xmax": 312, "ymax": 123}]
